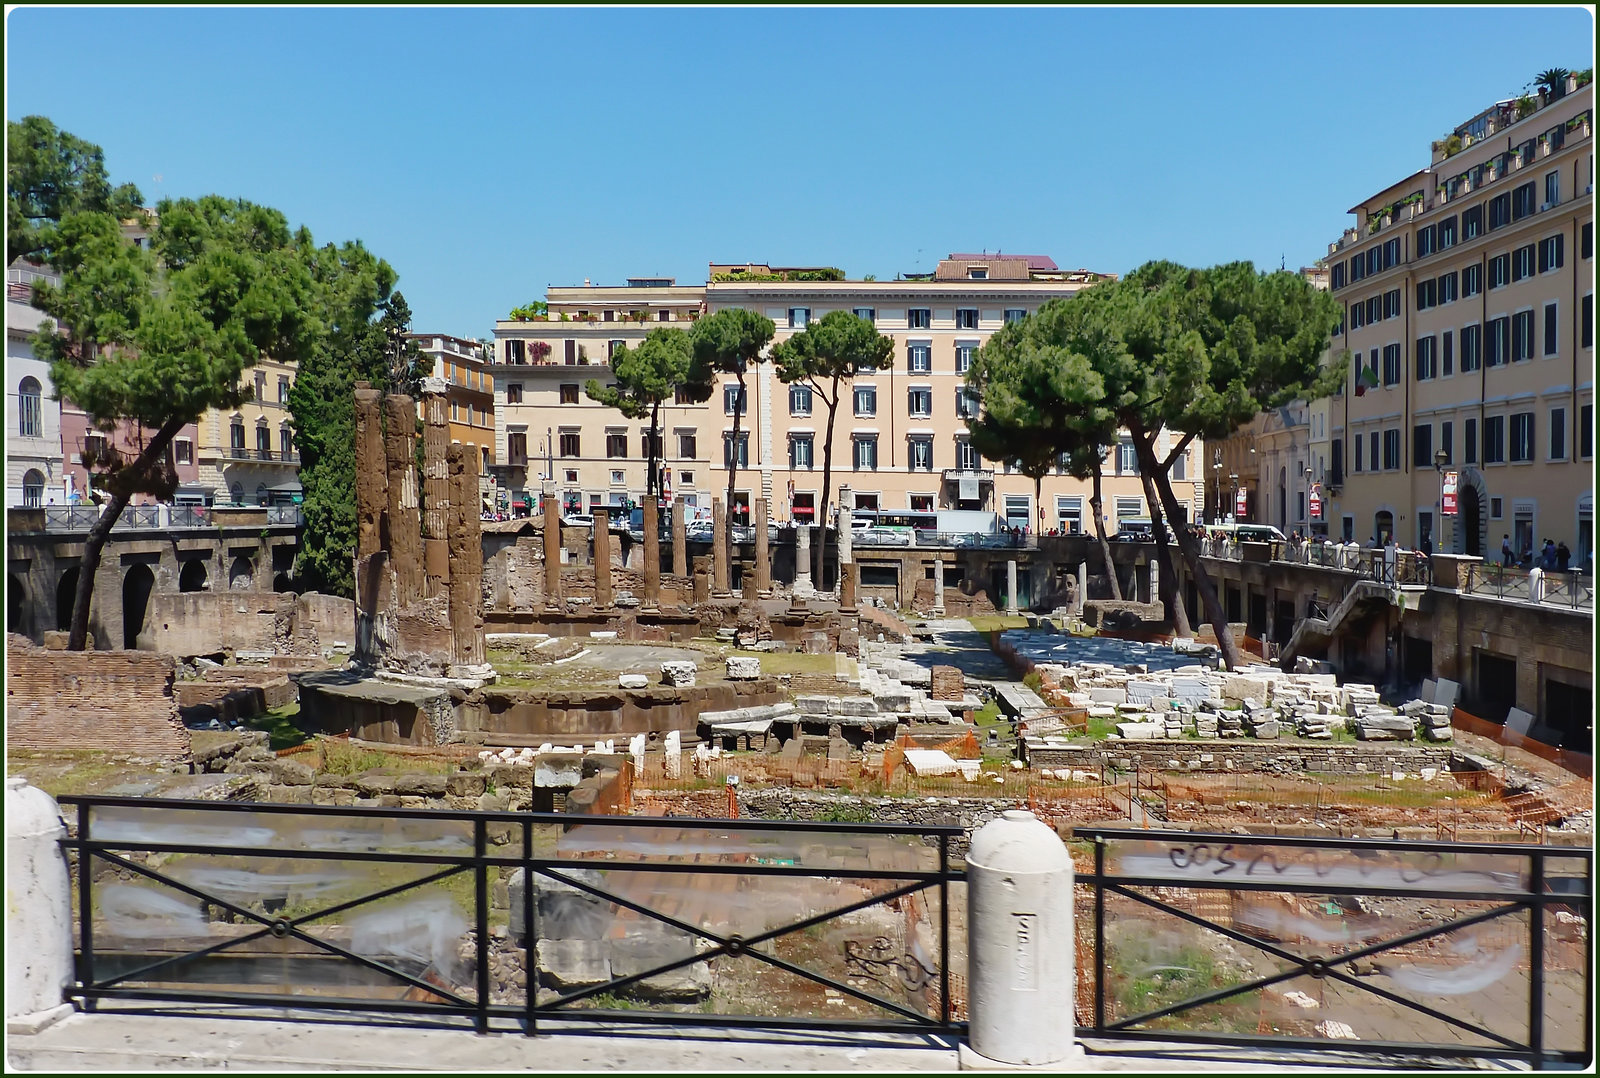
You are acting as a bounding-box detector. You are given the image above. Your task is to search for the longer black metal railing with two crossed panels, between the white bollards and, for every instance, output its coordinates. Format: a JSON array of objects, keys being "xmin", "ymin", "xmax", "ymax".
[{"xmin": 59, "ymin": 795, "xmax": 965, "ymax": 1035}]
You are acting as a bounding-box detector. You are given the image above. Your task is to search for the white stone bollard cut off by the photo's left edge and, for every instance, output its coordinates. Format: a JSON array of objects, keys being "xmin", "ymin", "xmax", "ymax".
[{"xmin": 5, "ymin": 776, "xmax": 72, "ymax": 1033}]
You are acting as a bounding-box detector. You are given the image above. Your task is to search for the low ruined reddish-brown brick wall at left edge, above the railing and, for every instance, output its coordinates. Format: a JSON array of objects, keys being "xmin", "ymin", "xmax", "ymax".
[{"xmin": 6, "ymin": 635, "xmax": 189, "ymax": 760}]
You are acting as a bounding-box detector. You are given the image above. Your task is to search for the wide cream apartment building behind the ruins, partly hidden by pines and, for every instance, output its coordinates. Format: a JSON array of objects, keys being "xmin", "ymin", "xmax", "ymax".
[{"xmin": 494, "ymin": 254, "xmax": 1205, "ymax": 531}]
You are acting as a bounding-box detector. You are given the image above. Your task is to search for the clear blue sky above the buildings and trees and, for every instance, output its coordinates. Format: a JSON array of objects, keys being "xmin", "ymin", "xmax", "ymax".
[{"xmin": 6, "ymin": 6, "xmax": 1594, "ymax": 336}]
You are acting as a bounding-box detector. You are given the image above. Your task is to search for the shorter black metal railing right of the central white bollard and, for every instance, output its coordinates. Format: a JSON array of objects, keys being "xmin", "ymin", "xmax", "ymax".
[{"xmin": 1074, "ymin": 827, "xmax": 1594, "ymax": 1068}]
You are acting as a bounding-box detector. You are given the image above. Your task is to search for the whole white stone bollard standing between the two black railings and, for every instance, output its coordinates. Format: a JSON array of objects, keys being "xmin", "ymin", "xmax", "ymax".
[{"xmin": 962, "ymin": 809, "xmax": 1082, "ymax": 1068}]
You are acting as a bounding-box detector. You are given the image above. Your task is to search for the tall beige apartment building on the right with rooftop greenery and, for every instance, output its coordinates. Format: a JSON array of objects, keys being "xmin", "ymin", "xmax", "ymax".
[{"xmin": 1325, "ymin": 82, "xmax": 1594, "ymax": 565}]
